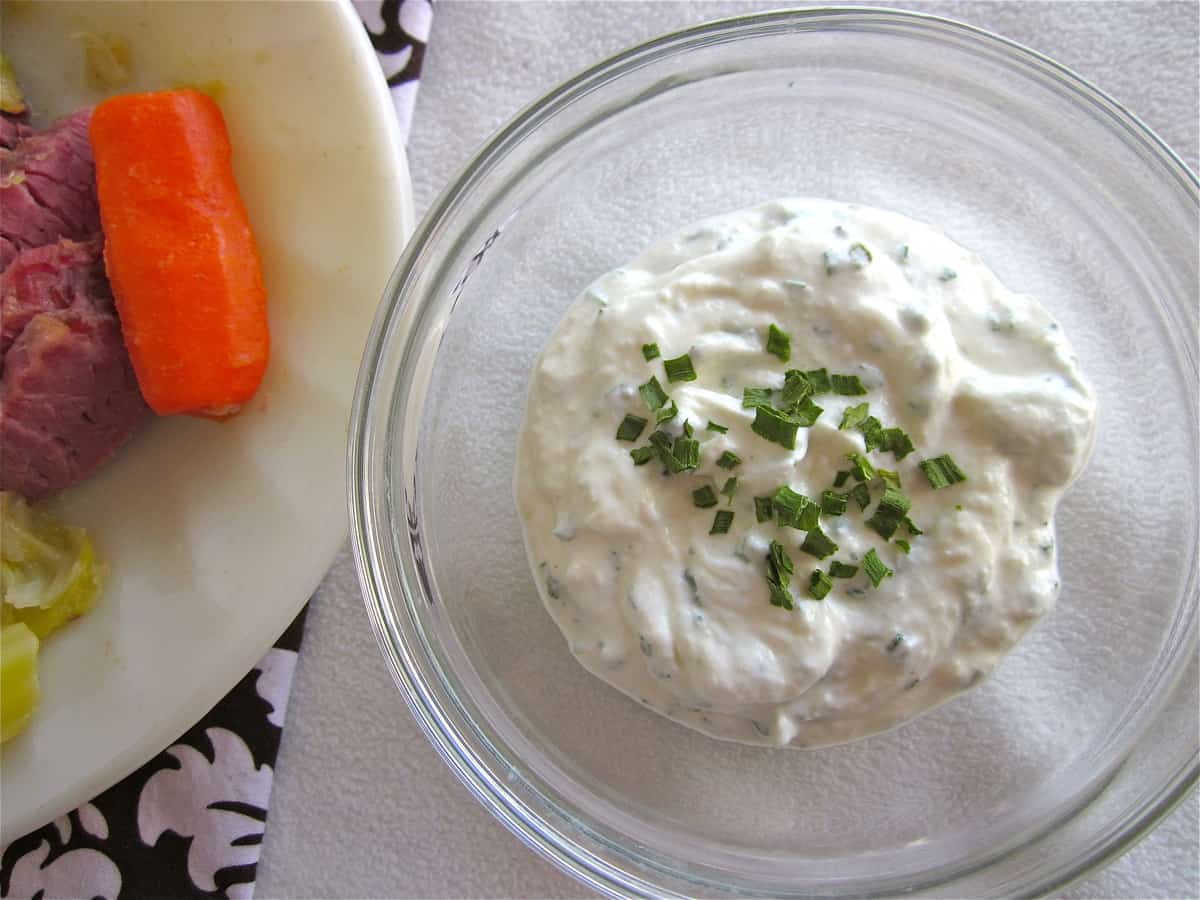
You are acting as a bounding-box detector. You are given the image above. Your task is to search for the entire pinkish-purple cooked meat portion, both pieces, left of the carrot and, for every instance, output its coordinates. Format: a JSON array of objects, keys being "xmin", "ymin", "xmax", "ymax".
[{"xmin": 0, "ymin": 62, "xmax": 150, "ymax": 499}]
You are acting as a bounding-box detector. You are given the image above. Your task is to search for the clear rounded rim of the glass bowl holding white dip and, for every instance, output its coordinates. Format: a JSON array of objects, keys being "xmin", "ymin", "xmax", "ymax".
[{"xmin": 347, "ymin": 6, "xmax": 1200, "ymax": 895}]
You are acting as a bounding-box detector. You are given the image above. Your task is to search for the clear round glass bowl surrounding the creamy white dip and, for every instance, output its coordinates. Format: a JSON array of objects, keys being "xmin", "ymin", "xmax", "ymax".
[{"xmin": 350, "ymin": 10, "xmax": 1200, "ymax": 896}]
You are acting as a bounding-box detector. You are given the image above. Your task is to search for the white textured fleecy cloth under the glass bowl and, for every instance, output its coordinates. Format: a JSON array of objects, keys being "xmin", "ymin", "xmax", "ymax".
[{"xmin": 257, "ymin": 1, "xmax": 1200, "ymax": 898}]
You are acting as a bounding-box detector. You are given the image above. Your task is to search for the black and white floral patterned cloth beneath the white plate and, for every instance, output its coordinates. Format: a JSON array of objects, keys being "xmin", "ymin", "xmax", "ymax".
[{"xmin": 0, "ymin": 0, "xmax": 432, "ymax": 900}]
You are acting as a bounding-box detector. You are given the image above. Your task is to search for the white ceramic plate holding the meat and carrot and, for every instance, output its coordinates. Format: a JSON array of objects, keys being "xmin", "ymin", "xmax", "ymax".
[{"xmin": 0, "ymin": 2, "xmax": 413, "ymax": 842}]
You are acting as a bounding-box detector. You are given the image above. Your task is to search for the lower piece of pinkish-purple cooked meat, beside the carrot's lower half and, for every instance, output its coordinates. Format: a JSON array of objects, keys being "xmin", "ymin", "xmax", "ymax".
[{"xmin": 0, "ymin": 238, "xmax": 150, "ymax": 499}]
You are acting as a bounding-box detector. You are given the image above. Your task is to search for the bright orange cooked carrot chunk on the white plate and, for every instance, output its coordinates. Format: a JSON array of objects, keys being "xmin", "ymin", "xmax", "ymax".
[{"xmin": 90, "ymin": 90, "xmax": 270, "ymax": 418}]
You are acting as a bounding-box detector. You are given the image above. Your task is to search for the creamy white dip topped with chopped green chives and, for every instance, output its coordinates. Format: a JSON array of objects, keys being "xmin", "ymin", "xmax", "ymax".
[{"xmin": 516, "ymin": 199, "xmax": 1096, "ymax": 746}]
